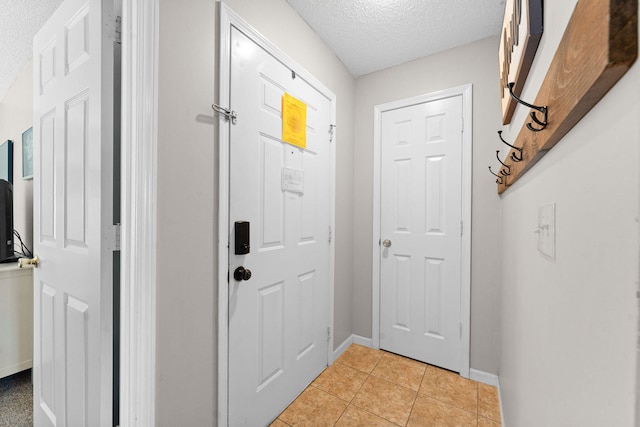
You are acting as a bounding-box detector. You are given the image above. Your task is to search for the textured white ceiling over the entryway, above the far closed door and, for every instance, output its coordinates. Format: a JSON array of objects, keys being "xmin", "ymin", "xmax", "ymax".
[{"xmin": 287, "ymin": 0, "xmax": 504, "ymax": 77}]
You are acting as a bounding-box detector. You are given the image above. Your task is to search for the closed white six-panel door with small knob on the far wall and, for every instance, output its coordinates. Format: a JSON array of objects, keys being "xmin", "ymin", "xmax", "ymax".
[{"xmin": 380, "ymin": 95, "xmax": 462, "ymax": 372}]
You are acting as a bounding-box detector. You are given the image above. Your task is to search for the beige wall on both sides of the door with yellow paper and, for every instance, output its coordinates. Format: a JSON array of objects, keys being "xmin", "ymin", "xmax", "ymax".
[{"xmin": 156, "ymin": 0, "xmax": 355, "ymax": 426}]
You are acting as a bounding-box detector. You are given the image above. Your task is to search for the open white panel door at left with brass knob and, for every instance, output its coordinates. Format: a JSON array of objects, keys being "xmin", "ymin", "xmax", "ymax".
[{"xmin": 33, "ymin": 0, "xmax": 115, "ymax": 427}]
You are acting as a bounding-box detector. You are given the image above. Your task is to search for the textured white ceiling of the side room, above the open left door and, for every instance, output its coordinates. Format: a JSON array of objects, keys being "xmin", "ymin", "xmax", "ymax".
[{"xmin": 0, "ymin": 0, "xmax": 62, "ymax": 99}]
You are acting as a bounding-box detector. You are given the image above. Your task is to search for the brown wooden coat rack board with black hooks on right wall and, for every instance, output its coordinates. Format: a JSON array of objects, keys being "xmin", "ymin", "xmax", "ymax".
[{"xmin": 498, "ymin": 0, "xmax": 638, "ymax": 193}]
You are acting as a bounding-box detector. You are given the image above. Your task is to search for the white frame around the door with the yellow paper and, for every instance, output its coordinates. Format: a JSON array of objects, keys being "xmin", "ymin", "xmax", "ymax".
[{"xmin": 217, "ymin": 2, "xmax": 336, "ymax": 426}]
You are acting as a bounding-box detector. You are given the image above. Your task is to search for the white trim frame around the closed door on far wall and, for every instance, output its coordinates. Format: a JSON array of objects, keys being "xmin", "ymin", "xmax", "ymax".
[{"xmin": 371, "ymin": 84, "xmax": 473, "ymax": 378}]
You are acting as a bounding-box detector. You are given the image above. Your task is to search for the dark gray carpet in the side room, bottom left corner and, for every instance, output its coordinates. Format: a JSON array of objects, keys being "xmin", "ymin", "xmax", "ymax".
[{"xmin": 0, "ymin": 369, "xmax": 33, "ymax": 427}]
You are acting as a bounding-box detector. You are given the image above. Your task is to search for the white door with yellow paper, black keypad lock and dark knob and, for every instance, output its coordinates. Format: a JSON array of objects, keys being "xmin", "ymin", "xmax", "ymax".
[{"xmin": 228, "ymin": 27, "xmax": 331, "ymax": 426}]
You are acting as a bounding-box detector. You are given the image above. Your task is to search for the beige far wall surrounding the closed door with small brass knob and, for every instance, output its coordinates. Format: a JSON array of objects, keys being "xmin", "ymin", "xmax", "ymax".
[{"xmin": 353, "ymin": 37, "xmax": 500, "ymax": 374}]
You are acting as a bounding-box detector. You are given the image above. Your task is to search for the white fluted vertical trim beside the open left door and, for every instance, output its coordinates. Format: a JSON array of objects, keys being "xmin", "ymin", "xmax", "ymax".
[{"xmin": 120, "ymin": 0, "xmax": 158, "ymax": 427}]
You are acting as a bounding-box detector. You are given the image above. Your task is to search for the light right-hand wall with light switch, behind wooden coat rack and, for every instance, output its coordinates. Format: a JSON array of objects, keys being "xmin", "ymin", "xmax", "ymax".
[{"xmin": 500, "ymin": 0, "xmax": 640, "ymax": 427}]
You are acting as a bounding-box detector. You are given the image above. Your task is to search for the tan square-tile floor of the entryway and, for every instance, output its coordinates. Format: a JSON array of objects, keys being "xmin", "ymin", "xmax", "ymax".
[{"xmin": 271, "ymin": 344, "xmax": 501, "ymax": 427}]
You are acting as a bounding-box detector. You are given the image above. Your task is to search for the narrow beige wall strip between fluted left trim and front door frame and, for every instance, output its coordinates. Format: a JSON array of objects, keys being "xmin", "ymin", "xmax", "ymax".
[{"xmin": 156, "ymin": 0, "xmax": 217, "ymax": 426}]
